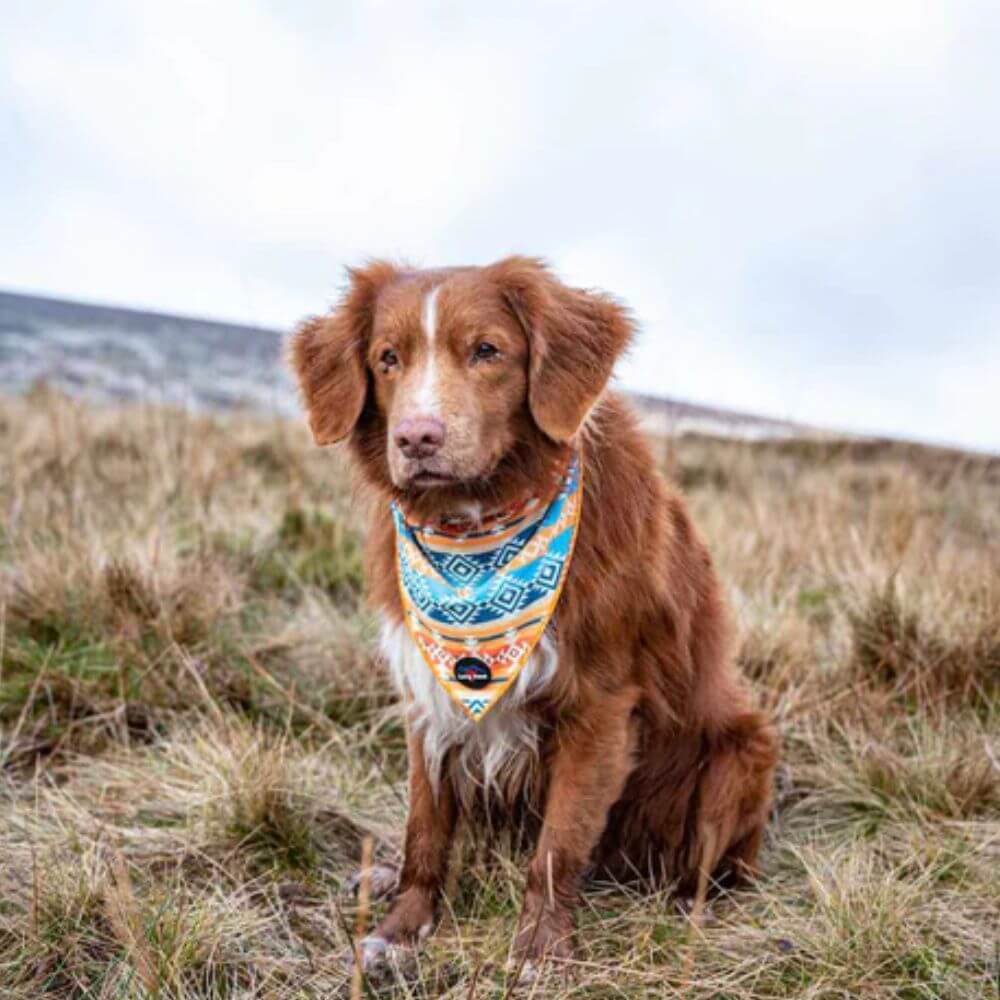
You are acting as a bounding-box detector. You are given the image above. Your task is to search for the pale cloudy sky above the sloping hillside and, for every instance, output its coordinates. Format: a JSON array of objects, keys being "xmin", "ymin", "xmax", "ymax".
[{"xmin": 0, "ymin": 0, "xmax": 1000, "ymax": 451}]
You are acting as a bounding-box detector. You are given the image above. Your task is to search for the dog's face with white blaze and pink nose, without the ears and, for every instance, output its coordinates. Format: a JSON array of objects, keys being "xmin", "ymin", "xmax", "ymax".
[{"xmin": 367, "ymin": 270, "xmax": 530, "ymax": 489}]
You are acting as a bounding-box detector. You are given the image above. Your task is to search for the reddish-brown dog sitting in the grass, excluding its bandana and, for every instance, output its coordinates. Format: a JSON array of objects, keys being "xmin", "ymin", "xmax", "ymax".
[{"xmin": 289, "ymin": 257, "xmax": 777, "ymax": 966}]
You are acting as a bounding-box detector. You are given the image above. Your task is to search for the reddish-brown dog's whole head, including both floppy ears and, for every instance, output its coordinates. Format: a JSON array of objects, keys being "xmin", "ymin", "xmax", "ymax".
[{"xmin": 290, "ymin": 257, "xmax": 632, "ymax": 494}]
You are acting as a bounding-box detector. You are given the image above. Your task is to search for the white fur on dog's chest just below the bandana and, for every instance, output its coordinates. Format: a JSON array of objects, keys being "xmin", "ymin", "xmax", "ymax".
[{"xmin": 381, "ymin": 622, "xmax": 559, "ymax": 790}]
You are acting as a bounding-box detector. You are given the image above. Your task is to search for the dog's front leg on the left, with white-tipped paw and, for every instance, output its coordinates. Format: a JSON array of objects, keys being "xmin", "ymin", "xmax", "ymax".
[{"xmin": 361, "ymin": 730, "xmax": 456, "ymax": 965}]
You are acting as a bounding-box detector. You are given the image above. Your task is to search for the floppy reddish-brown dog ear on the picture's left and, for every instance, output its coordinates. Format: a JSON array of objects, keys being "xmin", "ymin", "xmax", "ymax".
[{"xmin": 288, "ymin": 261, "xmax": 397, "ymax": 445}]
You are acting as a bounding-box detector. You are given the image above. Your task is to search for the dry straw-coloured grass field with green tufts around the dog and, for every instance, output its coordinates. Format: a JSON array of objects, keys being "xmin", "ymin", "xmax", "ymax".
[{"xmin": 0, "ymin": 391, "xmax": 1000, "ymax": 1000}]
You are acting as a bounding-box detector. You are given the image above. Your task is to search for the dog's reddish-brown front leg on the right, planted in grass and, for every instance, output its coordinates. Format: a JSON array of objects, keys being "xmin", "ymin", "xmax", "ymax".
[{"xmin": 515, "ymin": 690, "xmax": 636, "ymax": 959}]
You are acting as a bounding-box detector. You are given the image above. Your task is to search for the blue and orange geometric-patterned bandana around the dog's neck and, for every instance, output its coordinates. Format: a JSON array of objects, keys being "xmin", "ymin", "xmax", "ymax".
[{"xmin": 392, "ymin": 455, "xmax": 583, "ymax": 721}]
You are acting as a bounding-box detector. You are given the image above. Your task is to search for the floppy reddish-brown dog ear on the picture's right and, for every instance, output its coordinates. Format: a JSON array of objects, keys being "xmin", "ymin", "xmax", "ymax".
[{"xmin": 487, "ymin": 257, "xmax": 633, "ymax": 442}]
